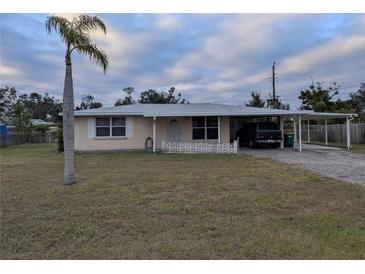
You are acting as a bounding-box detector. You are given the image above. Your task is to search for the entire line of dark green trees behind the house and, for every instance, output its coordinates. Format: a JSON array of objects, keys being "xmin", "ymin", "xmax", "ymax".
[{"xmin": 0, "ymin": 83, "xmax": 365, "ymax": 133}]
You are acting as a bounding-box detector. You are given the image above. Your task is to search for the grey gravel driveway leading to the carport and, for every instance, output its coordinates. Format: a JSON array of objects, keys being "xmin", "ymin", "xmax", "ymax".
[{"xmin": 241, "ymin": 145, "xmax": 365, "ymax": 185}]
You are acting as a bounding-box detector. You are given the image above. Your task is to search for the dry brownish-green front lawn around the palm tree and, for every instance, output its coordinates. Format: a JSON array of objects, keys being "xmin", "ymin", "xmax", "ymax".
[{"xmin": 0, "ymin": 145, "xmax": 365, "ymax": 259}]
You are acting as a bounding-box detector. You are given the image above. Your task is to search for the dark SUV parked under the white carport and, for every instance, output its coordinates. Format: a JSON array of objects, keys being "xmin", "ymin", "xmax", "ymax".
[{"xmin": 236, "ymin": 122, "xmax": 282, "ymax": 148}]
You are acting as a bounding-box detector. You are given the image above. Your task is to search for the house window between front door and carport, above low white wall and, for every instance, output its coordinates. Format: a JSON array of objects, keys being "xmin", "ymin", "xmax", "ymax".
[{"xmin": 193, "ymin": 116, "xmax": 218, "ymax": 140}]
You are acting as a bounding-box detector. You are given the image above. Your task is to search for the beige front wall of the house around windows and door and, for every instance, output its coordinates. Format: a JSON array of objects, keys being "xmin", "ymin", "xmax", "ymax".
[{"xmin": 75, "ymin": 116, "xmax": 229, "ymax": 151}]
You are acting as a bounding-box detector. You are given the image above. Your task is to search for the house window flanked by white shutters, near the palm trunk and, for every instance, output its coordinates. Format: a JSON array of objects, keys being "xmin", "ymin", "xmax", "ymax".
[{"xmin": 96, "ymin": 117, "xmax": 125, "ymax": 137}]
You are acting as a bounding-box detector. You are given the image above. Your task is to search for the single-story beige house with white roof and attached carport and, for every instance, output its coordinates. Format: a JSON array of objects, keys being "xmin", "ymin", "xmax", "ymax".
[{"xmin": 74, "ymin": 104, "xmax": 356, "ymax": 151}]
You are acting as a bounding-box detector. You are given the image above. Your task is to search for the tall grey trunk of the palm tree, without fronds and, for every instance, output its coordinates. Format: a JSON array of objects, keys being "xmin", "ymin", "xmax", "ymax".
[{"xmin": 62, "ymin": 51, "xmax": 75, "ymax": 185}]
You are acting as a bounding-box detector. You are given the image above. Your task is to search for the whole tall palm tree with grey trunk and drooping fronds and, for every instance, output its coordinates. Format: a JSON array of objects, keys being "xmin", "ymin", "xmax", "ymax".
[{"xmin": 46, "ymin": 15, "xmax": 108, "ymax": 185}]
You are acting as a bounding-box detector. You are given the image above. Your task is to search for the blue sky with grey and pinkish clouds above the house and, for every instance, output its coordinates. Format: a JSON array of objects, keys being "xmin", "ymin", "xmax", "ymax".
[{"xmin": 0, "ymin": 14, "xmax": 365, "ymax": 108}]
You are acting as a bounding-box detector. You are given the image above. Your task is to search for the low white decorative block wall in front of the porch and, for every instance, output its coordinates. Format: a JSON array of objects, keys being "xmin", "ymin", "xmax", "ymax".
[{"xmin": 161, "ymin": 141, "xmax": 238, "ymax": 154}]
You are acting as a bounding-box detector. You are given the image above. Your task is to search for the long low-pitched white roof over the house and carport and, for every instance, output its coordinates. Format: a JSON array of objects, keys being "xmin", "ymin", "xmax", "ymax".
[{"xmin": 75, "ymin": 104, "xmax": 356, "ymax": 118}]
